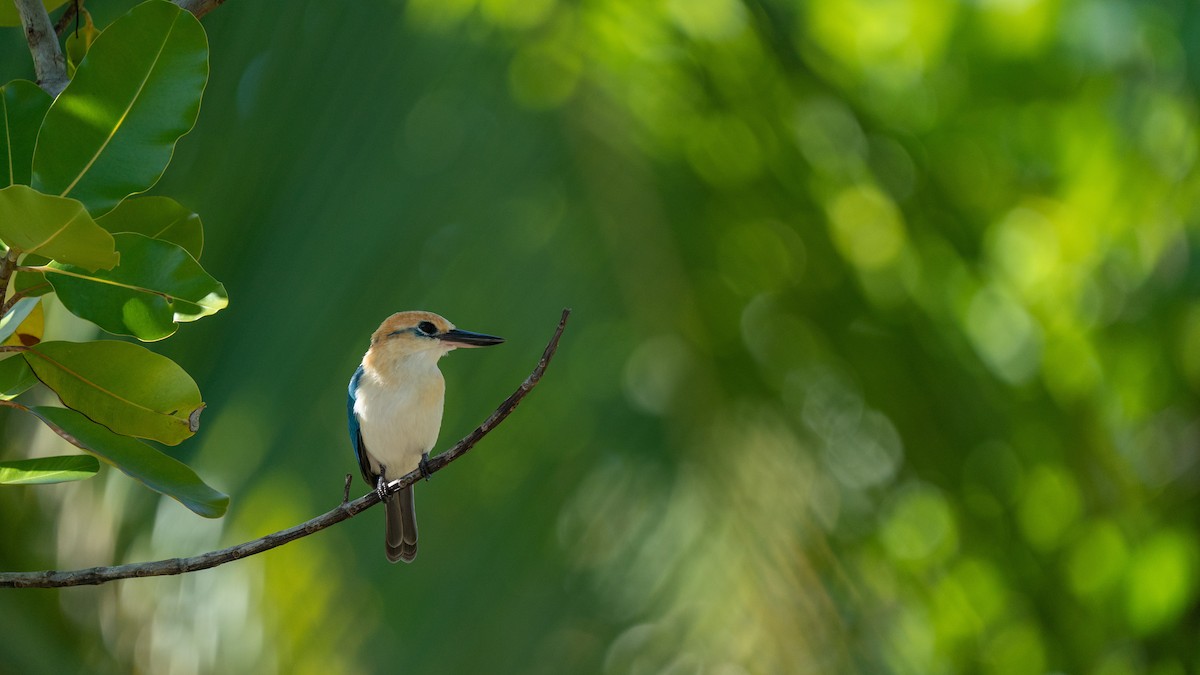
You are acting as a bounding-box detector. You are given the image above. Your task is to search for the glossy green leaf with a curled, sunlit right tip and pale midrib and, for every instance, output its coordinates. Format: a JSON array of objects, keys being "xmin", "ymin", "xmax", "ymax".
[{"xmin": 44, "ymin": 232, "xmax": 229, "ymax": 341}]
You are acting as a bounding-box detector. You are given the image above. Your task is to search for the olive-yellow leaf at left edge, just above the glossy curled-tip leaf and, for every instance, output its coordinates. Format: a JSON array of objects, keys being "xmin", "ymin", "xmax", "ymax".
[{"xmin": 0, "ymin": 185, "xmax": 119, "ymax": 270}]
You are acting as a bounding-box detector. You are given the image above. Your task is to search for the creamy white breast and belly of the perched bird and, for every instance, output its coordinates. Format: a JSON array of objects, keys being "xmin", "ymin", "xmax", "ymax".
[{"xmin": 354, "ymin": 359, "xmax": 445, "ymax": 479}]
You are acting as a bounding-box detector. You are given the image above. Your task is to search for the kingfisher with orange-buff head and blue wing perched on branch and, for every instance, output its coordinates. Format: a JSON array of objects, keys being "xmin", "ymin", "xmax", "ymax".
[{"xmin": 346, "ymin": 311, "xmax": 504, "ymax": 562}]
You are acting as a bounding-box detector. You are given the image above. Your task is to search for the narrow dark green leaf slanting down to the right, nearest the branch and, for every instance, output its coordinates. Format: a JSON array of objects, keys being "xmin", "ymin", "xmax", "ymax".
[{"xmin": 30, "ymin": 407, "xmax": 229, "ymax": 518}]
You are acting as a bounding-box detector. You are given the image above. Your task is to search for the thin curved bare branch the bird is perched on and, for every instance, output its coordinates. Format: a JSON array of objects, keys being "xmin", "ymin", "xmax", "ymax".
[{"xmin": 0, "ymin": 309, "xmax": 571, "ymax": 589}]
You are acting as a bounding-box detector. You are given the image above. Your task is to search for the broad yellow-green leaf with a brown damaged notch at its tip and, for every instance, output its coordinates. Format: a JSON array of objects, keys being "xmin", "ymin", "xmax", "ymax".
[{"xmin": 22, "ymin": 340, "xmax": 204, "ymax": 446}]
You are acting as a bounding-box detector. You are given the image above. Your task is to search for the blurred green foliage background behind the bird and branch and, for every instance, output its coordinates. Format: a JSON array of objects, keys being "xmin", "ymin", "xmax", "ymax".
[{"xmin": 0, "ymin": 0, "xmax": 1200, "ymax": 674}]
